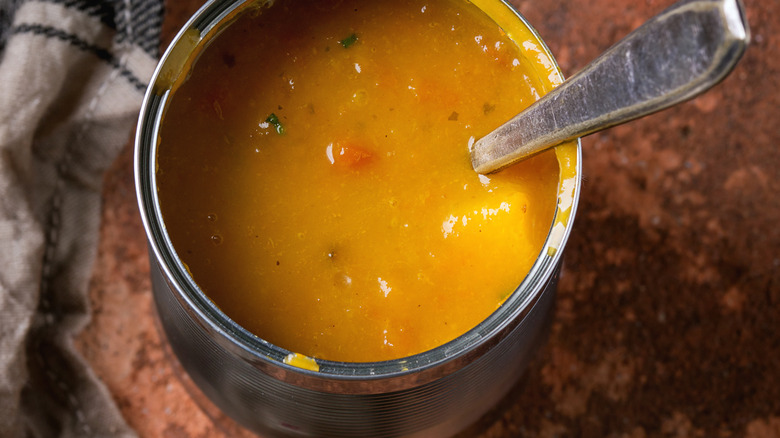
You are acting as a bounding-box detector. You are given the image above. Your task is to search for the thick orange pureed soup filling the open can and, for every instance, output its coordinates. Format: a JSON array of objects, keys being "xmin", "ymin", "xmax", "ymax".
[{"xmin": 157, "ymin": 0, "xmax": 558, "ymax": 362}]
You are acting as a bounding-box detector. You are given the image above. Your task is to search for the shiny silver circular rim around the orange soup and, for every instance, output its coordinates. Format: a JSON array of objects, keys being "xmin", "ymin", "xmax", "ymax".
[{"xmin": 136, "ymin": 0, "xmax": 581, "ymax": 379}]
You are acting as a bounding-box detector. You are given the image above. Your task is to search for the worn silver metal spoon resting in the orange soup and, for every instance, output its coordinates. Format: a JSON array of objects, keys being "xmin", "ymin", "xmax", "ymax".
[{"xmin": 471, "ymin": 0, "xmax": 750, "ymax": 174}]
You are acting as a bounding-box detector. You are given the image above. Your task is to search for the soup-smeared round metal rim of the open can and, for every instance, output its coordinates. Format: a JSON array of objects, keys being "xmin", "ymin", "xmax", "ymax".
[{"xmin": 134, "ymin": 0, "xmax": 582, "ymax": 392}]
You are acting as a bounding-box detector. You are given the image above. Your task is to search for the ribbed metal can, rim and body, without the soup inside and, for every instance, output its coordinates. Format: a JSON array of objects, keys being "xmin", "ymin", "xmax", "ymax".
[{"xmin": 135, "ymin": 0, "xmax": 581, "ymax": 437}]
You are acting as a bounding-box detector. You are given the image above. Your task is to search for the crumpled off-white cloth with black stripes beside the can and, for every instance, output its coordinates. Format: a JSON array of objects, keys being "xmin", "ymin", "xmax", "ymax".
[{"xmin": 0, "ymin": 0, "xmax": 162, "ymax": 438}]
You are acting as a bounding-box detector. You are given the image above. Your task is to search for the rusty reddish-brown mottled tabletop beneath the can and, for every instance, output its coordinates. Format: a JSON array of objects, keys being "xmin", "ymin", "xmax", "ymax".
[{"xmin": 77, "ymin": 0, "xmax": 780, "ymax": 438}]
